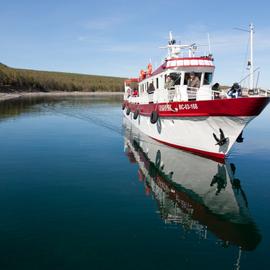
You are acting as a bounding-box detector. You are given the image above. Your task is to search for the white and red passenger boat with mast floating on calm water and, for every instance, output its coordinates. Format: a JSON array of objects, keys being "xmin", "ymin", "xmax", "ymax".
[{"xmin": 123, "ymin": 25, "xmax": 269, "ymax": 159}]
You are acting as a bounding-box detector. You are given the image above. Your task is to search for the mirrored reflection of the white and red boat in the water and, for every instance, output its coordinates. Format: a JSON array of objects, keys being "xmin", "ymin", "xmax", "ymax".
[{"xmin": 124, "ymin": 118, "xmax": 261, "ymax": 250}]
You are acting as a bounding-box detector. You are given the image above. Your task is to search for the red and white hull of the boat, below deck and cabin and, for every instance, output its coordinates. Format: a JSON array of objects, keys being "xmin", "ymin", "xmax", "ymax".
[{"xmin": 124, "ymin": 98, "xmax": 269, "ymax": 159}]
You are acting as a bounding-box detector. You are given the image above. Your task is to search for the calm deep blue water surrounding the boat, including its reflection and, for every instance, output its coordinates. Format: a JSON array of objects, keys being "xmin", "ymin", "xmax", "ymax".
[{"xmin": 0, "ymin": 98, "xmax": 270, "ymax": 270}]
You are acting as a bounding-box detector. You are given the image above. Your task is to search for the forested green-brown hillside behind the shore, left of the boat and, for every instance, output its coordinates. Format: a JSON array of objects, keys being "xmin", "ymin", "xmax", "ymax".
[{"xmin": 0, "ymin": 63, "xmax": 124, "ymax": 92}]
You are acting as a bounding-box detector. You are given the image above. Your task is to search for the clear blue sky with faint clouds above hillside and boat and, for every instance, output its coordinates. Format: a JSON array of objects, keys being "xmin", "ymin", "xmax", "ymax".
[{"xmin": 0, "ymin": 0, "xmax": 270, "ymax": 88}]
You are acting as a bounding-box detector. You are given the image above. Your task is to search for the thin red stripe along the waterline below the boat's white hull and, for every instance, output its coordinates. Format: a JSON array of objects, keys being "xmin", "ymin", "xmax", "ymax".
[{"xmin": 151, "ymin": 137, "xmax": 226, "ymax": 163}]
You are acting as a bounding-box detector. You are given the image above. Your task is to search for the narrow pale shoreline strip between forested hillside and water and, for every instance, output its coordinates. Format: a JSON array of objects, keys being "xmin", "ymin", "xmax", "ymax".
[{"xmin": 0, "ymin": 91, "xmax": 124, "ymax": 102}]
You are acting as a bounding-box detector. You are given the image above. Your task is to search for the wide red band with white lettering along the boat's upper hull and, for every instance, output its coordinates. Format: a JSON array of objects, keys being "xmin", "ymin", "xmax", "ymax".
[{"xmin": 125, "ymin": 97, "xmax": 270, "ymax": 117}]
